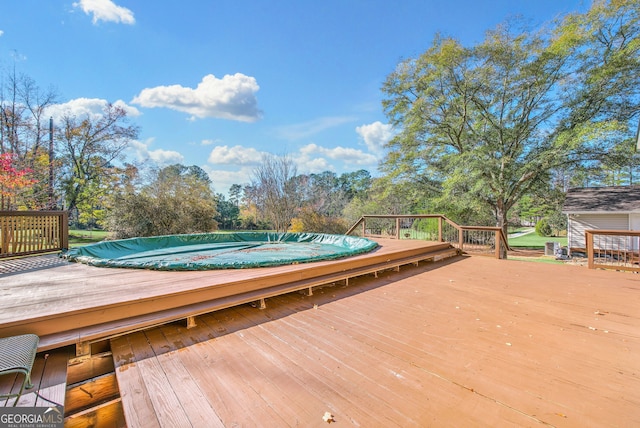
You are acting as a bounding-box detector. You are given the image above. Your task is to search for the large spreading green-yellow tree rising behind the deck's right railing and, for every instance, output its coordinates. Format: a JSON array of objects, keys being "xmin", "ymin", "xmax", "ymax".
[{"xmin": 383, "ymin": 0, "xmax": 640, "ymax": 244}]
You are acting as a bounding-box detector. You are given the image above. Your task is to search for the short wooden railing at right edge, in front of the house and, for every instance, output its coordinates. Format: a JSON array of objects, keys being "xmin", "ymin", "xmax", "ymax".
[{"xmin": 584, "ymin": 230, "xmax": 640, "ymax": 272}]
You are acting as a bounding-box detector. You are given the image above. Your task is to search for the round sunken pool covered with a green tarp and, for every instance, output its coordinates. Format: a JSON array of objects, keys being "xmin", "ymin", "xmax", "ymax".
[{"xmin": 63, "ymin": 232, "xmax": 378, "ymax": 270}]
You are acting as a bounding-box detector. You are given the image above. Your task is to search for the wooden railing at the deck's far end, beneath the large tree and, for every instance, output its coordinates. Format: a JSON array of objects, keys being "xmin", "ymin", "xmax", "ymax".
[{"xmin": 346, "ymin": 214, "xmax": 509, "ymax": 259}]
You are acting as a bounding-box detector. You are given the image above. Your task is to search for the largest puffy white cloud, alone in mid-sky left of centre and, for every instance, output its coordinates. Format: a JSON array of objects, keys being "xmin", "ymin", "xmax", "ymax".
[{"xmin": 132, "ymin": 73, "xmax": 262, "ymax": 122}]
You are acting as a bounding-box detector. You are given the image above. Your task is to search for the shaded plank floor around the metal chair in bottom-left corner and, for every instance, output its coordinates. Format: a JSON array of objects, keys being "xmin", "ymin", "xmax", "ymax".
[{"xmin": 0, "ymin": 348, "xmax": 72, "ymax": 407}]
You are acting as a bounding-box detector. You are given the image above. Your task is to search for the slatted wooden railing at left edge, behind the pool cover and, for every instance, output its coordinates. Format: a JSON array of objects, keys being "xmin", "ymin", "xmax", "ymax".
[{"xmin": 0, "ymin": 211, "xmax": 69, "ymax": 258}]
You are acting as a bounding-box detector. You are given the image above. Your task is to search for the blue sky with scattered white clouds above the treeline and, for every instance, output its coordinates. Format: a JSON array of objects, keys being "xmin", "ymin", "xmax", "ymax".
[{"xmin": 0, "ymin": 0, "xmax": 588, "ymax": 193}]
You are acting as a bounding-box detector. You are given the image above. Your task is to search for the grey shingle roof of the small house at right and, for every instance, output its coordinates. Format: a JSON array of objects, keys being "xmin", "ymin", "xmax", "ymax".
[{"xmin": 562, "ymin": 186, "xmax": 640, "ymax": 213}]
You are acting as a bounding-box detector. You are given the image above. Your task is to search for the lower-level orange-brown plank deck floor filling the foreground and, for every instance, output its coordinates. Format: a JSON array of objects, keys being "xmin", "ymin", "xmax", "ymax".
[{"xmin": 112, "ymin": 257, "xmax": 640, "ymax": 428}]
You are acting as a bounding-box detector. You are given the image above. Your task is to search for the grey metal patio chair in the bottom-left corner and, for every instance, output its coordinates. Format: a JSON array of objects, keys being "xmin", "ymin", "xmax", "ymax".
[{"xmin": 0, "ymin": 334, "xmax": 40, "ymax": 406}]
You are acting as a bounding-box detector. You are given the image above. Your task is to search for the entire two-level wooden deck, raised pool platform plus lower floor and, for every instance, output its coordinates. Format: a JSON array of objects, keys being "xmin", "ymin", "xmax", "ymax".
[{"xmin": 0, "ymin": 241, "xmax": 640, "ymax": 428}]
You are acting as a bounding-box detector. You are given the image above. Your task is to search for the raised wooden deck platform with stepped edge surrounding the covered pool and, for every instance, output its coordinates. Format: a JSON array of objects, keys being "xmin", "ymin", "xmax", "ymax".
[{"xmin": 0, "ymin": 240, "xmax": 455, "ymax": 352}]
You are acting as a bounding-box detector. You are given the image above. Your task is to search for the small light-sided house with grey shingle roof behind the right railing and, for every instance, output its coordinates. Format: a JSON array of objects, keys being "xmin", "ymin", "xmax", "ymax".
[{"xmin": 562, "ymin": 186, "xmax": 640, "ymax": 253}]
